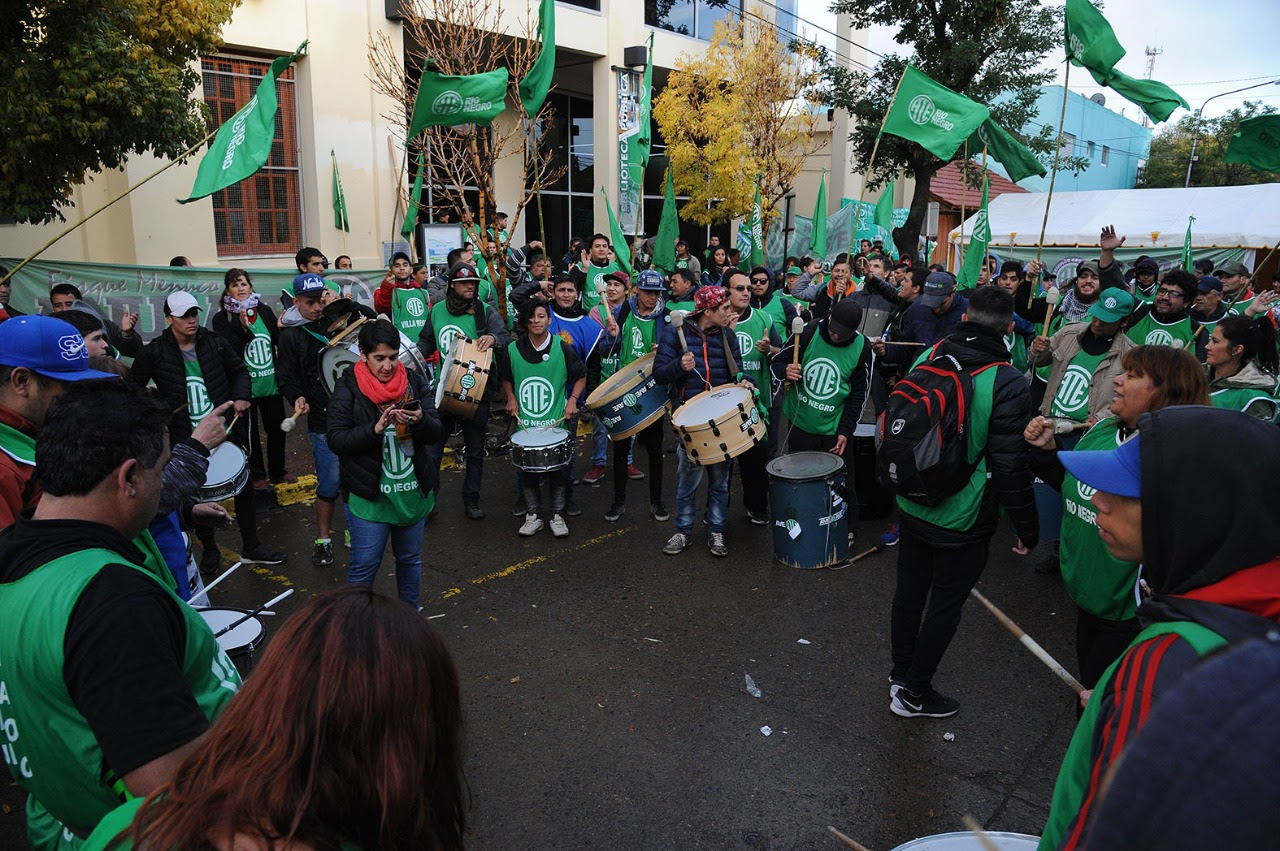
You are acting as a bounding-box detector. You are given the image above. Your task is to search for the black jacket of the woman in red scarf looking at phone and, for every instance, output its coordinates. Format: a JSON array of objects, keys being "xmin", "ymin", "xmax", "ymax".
[{"xmin": 328, "ymin": 369, "xmax": 443, "ymax": 499}]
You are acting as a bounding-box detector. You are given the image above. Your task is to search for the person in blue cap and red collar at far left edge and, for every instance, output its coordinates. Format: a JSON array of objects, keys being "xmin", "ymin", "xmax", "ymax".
[{"xmin": 0, "ymin": 316, "xmax": 115, "ymax": 529}]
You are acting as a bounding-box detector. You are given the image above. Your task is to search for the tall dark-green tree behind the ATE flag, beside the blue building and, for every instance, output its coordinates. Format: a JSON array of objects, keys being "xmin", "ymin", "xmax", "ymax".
[{"xmin": 813, "ymin": 0, "xmax": 1084, "ymax": 255}]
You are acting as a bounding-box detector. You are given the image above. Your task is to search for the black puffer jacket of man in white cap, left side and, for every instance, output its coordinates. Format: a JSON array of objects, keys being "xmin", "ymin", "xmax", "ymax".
[{"xmin": 129, "ymin": 328, "xmax": 251, "ymax": 445}]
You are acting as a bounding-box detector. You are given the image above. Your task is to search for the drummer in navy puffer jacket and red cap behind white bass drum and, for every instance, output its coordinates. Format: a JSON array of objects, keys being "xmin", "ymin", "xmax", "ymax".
[{"xmin": 653, "ymin": 284, "xmax": 751, "ymax": 557}]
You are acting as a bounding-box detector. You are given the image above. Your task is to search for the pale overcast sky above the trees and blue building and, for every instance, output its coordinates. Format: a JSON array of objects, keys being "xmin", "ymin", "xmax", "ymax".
[{"xmin": 797, "ymin": 0, "xmax": 1280, "ymax": 122}]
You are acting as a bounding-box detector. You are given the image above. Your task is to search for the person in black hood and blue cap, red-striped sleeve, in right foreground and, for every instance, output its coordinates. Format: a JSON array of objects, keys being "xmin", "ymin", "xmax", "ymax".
[{"xmin": 1039, "ymin": 406, "xmax": 1280, "ymax": 848}]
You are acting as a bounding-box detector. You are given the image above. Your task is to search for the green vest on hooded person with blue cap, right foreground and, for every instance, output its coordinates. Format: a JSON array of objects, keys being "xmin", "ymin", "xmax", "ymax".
[{"xmin": 1037, "ymin": 621, "xmax": 1226, "ymax": 851}]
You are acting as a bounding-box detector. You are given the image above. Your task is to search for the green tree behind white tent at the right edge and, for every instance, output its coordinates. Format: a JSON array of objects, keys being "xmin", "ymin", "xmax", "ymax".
[{"xmin": 1138, "ymin": 101, "xmax": 1275, "ymax": 188}]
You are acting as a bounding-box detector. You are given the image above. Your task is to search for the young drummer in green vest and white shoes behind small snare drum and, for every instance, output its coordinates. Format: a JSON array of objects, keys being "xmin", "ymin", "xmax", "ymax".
[{"xmin": 502, "ymin": 301, "xmax": 586, "ymax": 537}]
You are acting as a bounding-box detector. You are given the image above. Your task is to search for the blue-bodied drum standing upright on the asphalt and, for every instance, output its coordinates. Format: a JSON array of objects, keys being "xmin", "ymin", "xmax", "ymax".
[{"xmin": 765, "ymin": 452, "xmax": 849, "ymax": 569}]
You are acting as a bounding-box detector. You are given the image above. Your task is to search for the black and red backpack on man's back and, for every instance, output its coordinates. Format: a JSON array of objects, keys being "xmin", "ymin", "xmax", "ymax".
[{"xmin": 876, "ymin": 346, "xmax": 1000, "ymax": 505}]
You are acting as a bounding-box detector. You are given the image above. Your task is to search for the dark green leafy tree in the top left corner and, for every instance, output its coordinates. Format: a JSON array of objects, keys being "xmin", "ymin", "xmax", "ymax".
[{"xmin": 0, "ymin": 0, "xmax": 239, "ymax": 221}]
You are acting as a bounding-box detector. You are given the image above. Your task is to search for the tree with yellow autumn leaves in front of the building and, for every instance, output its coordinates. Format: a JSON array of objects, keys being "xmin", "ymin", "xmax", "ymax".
[{"xmin": 653, "ymin": 17, "xmax": 820, "ymax": 239}]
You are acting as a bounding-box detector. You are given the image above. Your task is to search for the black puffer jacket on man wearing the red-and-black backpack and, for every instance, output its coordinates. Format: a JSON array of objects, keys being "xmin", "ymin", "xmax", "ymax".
[{"xmin": 900, "ymin": 321, "xmax": 1039, "ymax": 548}]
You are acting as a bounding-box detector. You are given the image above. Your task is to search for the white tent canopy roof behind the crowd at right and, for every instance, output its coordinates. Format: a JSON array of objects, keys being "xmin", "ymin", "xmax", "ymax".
[{"xmin": 948, "ymin": 183, "xmax": 1280, "ymax": 250}]
